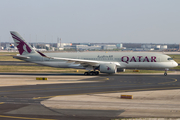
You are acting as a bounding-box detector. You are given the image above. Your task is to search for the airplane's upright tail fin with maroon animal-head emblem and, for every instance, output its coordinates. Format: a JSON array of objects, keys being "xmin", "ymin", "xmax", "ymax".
[{"xmin": 10, "ymin": 31, "xmax": 36, "ymax": 55}]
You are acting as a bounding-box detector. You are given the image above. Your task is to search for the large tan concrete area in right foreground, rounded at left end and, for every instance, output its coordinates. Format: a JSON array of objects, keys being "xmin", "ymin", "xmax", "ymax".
[{"xmin": 41, "ymin": 89, "xmax": 180, "ymax": 117}]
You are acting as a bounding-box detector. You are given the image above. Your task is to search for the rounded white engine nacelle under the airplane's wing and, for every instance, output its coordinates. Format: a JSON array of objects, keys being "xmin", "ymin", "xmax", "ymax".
[{"xmin": 99, "ymin": 63, "xmax": 117, "ymax": 73}]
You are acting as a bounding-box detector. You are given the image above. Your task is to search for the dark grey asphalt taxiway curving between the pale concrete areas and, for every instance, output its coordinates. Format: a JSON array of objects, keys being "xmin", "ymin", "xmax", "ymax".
[{"xmin": 0, "ymin": 73, "xmax": 180, "ymax": 120}]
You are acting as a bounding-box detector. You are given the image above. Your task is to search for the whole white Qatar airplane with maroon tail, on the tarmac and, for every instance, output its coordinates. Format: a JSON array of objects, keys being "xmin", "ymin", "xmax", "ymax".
[{"xmin": 10, "ymin": 31, "xmax": 178, "ymax": 76}]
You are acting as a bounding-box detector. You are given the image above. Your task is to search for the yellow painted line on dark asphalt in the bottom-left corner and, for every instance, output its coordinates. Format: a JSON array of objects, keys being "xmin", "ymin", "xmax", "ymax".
[{"xmin": 0, "ymin": 115, "xmax": 57, "ymax": 120}]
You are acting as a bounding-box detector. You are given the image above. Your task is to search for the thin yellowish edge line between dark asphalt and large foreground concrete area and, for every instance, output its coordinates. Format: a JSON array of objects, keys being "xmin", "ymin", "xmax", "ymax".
[{"xmin": 33, "ymin": 87, "xmax": 180, "ymax": 99}]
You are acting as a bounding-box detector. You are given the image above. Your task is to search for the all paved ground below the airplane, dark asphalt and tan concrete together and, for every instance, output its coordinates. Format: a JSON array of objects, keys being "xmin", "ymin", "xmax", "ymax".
[{"xmin": 0, "ymin": 73, "xmax": 180, "ymax": 120}]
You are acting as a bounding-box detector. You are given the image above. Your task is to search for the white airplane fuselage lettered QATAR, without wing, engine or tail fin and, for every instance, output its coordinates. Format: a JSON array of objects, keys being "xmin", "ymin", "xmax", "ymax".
[{"xmin": 24, "ymin": 52, "xmax": 178, "ymax": 69}]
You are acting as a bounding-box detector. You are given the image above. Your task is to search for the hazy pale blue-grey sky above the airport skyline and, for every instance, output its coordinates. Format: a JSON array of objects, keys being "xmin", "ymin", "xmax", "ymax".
[{"xmin": 0, "ymin": 0, "xmax": 180, "ymax": 44}]
